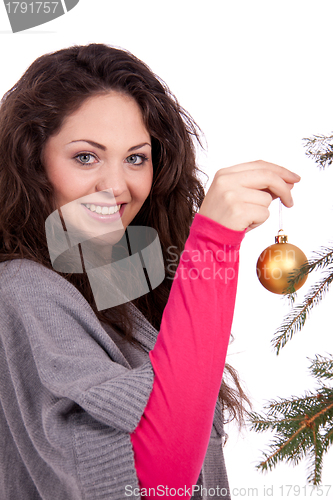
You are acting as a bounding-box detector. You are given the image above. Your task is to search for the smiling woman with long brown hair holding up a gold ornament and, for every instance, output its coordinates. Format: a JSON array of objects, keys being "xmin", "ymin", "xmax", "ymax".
[{"xmin": 0, "ymin": 44, "xmax": 300, "ymax": 500}]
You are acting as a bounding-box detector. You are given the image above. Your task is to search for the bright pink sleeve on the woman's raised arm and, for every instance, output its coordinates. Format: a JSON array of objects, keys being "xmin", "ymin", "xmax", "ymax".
[{"xmin": 131, "ymin": 214, "xmax": 245, "ymax": 498}]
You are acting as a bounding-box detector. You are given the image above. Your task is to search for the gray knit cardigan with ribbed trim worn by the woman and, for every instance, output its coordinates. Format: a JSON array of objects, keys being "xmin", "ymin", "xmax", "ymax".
[{"xmin": 0, "ymin": 259, "xmax": 230, "ymax": 500}]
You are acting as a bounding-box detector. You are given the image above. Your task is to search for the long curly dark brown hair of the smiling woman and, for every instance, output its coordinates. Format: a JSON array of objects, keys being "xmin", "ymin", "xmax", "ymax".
[{"xmin": 0, "ymin": 44, "xmax": 248, "ymax": 421}]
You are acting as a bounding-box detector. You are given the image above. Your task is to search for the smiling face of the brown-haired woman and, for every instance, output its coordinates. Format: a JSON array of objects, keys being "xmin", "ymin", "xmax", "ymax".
[{"xmin": 43, "ymin": 91, "xmax": 153, "ymax": 244}]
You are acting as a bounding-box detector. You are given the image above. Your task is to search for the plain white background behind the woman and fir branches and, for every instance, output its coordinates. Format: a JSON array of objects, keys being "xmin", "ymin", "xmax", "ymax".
[{"xmin": 0, "ymin": 0, "xmax": 333, "ymax": 499}]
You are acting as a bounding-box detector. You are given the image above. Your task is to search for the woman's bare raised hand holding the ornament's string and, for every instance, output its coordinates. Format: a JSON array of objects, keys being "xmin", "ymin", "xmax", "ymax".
[{"xmin": 199, "ymin": 160, "xmax": 300, "ymax": 231}]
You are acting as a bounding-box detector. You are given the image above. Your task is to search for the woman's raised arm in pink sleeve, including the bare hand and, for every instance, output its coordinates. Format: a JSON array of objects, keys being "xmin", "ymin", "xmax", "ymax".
[{"xmin": 131, "ymin": 161, "xmax": 299, "ymax": 496}]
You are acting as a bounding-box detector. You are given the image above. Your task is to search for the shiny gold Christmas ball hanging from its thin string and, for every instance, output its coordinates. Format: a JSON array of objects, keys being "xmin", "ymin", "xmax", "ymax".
[{"xmin": 257, "ymin": 201, "xmax": 308, "ymax": 294}]
